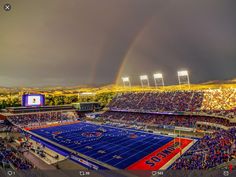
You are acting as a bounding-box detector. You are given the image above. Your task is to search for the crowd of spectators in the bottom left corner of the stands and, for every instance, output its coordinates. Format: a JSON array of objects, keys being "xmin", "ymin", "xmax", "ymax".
[{"xmin": 0, "ymin": 137, "xmax": 33, "ymax": 170}]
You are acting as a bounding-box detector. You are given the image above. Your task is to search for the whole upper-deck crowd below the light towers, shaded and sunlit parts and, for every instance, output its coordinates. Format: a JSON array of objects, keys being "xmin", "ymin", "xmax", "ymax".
[{"xmin": 109, "ymin": 88, "xmax": 236, "ymax": 118}]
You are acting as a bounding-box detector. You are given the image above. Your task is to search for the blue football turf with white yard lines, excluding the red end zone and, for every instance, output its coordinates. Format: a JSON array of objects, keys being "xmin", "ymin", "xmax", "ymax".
[{"xmin": 31, "ymin": 122, "xmax": 173, "ymax": 169}]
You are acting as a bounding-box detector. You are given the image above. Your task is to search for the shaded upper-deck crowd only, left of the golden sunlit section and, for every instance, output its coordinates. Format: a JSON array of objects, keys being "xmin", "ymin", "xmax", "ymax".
[{"xmin": 109, "ymin": 91, "xmax": 203, "ymax": 112}]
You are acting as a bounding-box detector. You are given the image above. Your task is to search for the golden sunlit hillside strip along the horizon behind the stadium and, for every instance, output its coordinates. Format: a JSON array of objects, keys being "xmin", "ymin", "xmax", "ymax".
[{"xmin": 0, "ymin": 79, "xmax": 236, "ymax": 94}]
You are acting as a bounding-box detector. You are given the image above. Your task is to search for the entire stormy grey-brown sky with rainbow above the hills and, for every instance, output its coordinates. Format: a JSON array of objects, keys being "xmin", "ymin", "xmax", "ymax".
[{"xmin": 0, "ymin": 0, "xmax": 236, "ymax": 87}]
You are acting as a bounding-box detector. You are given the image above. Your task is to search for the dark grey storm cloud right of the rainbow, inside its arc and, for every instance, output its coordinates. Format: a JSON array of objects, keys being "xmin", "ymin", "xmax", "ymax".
[{"xmin": 121, "ymin": 0, "xmax": 236, "ymax": 84}]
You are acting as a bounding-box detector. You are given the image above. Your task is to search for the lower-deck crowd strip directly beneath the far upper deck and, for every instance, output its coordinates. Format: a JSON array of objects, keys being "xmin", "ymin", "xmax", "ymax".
[{"xmin": 102, "ymin": 111, "xmax": 235, "ymax": 128}]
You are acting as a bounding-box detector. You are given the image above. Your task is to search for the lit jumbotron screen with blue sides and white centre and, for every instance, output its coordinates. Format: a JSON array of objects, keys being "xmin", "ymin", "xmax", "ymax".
[{"xmin": 22, "ymin": 94, "xmax": 45, "ymax": 106}]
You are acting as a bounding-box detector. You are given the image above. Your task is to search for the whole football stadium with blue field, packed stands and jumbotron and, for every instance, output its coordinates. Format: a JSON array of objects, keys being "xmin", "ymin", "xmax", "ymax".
[{"xmin": 0, "ymin": 84, "xmax": 236, "ymax": 176}]
